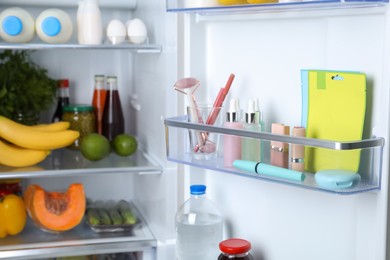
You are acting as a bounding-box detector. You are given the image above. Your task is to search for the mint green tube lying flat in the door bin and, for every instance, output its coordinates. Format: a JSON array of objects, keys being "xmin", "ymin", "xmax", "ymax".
[{"xmin": 233, "ymin": 160, "xmax": 305, "ymax": 182}]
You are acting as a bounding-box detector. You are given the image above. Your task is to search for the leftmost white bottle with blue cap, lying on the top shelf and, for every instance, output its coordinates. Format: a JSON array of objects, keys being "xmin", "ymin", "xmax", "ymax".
[{"xmin": 0, "ymin": 7, "xmax": 35, "ymax": 43}]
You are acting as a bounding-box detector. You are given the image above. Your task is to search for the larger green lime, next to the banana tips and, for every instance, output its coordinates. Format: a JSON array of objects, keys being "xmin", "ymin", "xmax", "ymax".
[{"xmin": 80, "ymin": 133, "xmax": 110, "ymax": 161}]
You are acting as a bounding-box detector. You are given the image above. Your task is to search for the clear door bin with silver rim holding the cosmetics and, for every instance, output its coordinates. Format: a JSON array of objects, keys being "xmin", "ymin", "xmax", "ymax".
[{"xmin": 164, "ymin": 116, "xmax": 384, "ymax": 195}]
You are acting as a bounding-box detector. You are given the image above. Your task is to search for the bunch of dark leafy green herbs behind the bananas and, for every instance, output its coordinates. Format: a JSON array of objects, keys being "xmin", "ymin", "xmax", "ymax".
[{"xmin": 0, "ymin": 50, "xmax": 56, "ymax": 124}]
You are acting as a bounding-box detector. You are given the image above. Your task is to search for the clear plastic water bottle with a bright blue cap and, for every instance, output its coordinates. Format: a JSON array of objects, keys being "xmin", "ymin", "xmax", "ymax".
[{"xmin": 175, "ymin": 185, "xmax": 223, "ymax": 260}]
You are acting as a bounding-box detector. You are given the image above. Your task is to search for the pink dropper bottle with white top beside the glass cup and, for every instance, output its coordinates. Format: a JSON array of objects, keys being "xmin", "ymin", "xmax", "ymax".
[{"xmin": 223, "ymin": 98, "xmax": 243, "ymax": 167}]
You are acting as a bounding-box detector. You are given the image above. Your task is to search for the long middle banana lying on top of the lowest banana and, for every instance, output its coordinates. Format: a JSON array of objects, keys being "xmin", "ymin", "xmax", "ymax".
[{"xmin": 0, "ymin": 116, "xmax": 80, "ymax": 150}]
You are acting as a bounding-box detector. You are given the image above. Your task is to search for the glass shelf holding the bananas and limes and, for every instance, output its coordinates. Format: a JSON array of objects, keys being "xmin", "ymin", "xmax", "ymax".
[{"xmin": 0, "ymin": 148, "xmax": 162, "ymax": 179}]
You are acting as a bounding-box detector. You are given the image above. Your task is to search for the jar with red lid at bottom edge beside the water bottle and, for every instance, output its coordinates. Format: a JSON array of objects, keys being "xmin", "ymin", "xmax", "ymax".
[{"xmin": 218, "ymin": 238, "xmax": 254, "ymax": 260}]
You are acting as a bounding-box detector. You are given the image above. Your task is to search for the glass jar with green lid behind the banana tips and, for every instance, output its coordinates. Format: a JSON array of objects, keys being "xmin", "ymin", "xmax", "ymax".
[{"xmin": 62, "ymin": 104, "xmax": 96, "ymax": 149}]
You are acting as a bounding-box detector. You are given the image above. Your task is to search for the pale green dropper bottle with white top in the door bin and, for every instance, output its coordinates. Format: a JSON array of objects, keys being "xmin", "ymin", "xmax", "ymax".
[{"xmin": 242, "ymin": 99, "xmax": 261, "ymax": 162}]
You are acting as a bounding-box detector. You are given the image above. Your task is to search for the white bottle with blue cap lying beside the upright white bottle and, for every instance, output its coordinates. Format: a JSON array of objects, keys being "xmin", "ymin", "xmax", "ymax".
[{"xmin": 35, "ymin": 8, "xmax": 73, "ymax": 43}]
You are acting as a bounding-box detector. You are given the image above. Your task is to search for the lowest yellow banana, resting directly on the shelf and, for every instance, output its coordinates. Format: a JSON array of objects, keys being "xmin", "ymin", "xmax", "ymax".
[{"xmin": 0, "ymin": 140, "xmax": 50, "ymax": 167}]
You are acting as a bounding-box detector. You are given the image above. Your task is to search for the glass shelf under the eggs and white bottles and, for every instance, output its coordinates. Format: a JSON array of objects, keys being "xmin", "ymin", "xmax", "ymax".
[{"xmin": 0, "ymin": 42, "xmax": 162, "ymax": 53}]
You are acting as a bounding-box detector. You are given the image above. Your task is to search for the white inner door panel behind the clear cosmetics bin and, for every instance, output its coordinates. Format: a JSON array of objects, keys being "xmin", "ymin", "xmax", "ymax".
[{"xmin": 179, "ymin": 5, "xmax": 390, "ymax": 260}]
